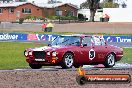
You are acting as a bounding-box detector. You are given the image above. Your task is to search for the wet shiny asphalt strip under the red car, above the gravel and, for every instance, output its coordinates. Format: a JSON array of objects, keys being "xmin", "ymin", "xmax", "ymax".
[{"xmin": 0, "ymin": 63, "xmax": 132, "ymax": 72}]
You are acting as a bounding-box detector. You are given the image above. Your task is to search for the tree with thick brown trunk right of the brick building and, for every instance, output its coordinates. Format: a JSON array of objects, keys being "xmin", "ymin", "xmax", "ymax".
[{"xmin": 80, "ymin": 0, "xmax": 100, "ymax": 22}]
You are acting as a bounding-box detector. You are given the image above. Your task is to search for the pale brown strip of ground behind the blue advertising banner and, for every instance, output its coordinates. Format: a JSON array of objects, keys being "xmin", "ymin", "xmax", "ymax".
[{"xmin": 0, "ymin": 22, "xmax": 132, "ymax": 34}]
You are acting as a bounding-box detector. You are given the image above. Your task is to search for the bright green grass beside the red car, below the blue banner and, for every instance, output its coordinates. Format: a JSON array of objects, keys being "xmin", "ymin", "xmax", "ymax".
[{"xmin": 0, "ymin": 42, "xmax": 132, "ymax": 69}]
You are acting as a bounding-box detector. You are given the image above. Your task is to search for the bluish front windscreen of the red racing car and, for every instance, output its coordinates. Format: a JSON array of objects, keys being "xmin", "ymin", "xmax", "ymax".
[{"xmin": 51, "ymin": 36, "xmax": 81, "ymax": 46}]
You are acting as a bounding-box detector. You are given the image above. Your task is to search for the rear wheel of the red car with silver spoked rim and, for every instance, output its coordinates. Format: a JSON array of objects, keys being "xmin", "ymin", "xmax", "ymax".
[{"xmin": 104, "ymin": 53, "xmax": 115, "ymax": 68}]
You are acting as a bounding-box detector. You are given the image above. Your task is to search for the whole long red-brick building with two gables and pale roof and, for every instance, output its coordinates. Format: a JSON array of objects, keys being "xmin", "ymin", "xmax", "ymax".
[{"xmin": 0, "ymin": 2, "xmax": 78, "ymax": 22}]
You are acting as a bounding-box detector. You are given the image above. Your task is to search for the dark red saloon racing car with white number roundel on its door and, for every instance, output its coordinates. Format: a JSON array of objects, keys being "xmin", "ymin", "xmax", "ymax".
[{"xmin": 24, "ymin": 35, "xmax": 123, "ymax": 69}]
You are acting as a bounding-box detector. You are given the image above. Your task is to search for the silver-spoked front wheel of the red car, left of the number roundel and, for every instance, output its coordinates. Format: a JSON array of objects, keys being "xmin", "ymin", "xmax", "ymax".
[{"xmin": 61, "ymin": 53, "xmax": 73, "ymax": 69}]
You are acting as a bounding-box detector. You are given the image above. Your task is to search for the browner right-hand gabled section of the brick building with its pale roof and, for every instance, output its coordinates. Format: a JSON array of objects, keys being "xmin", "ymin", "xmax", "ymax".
[{"xmin": 37, "ymin": 3, "xmax": 78, "ymax": 17}]
